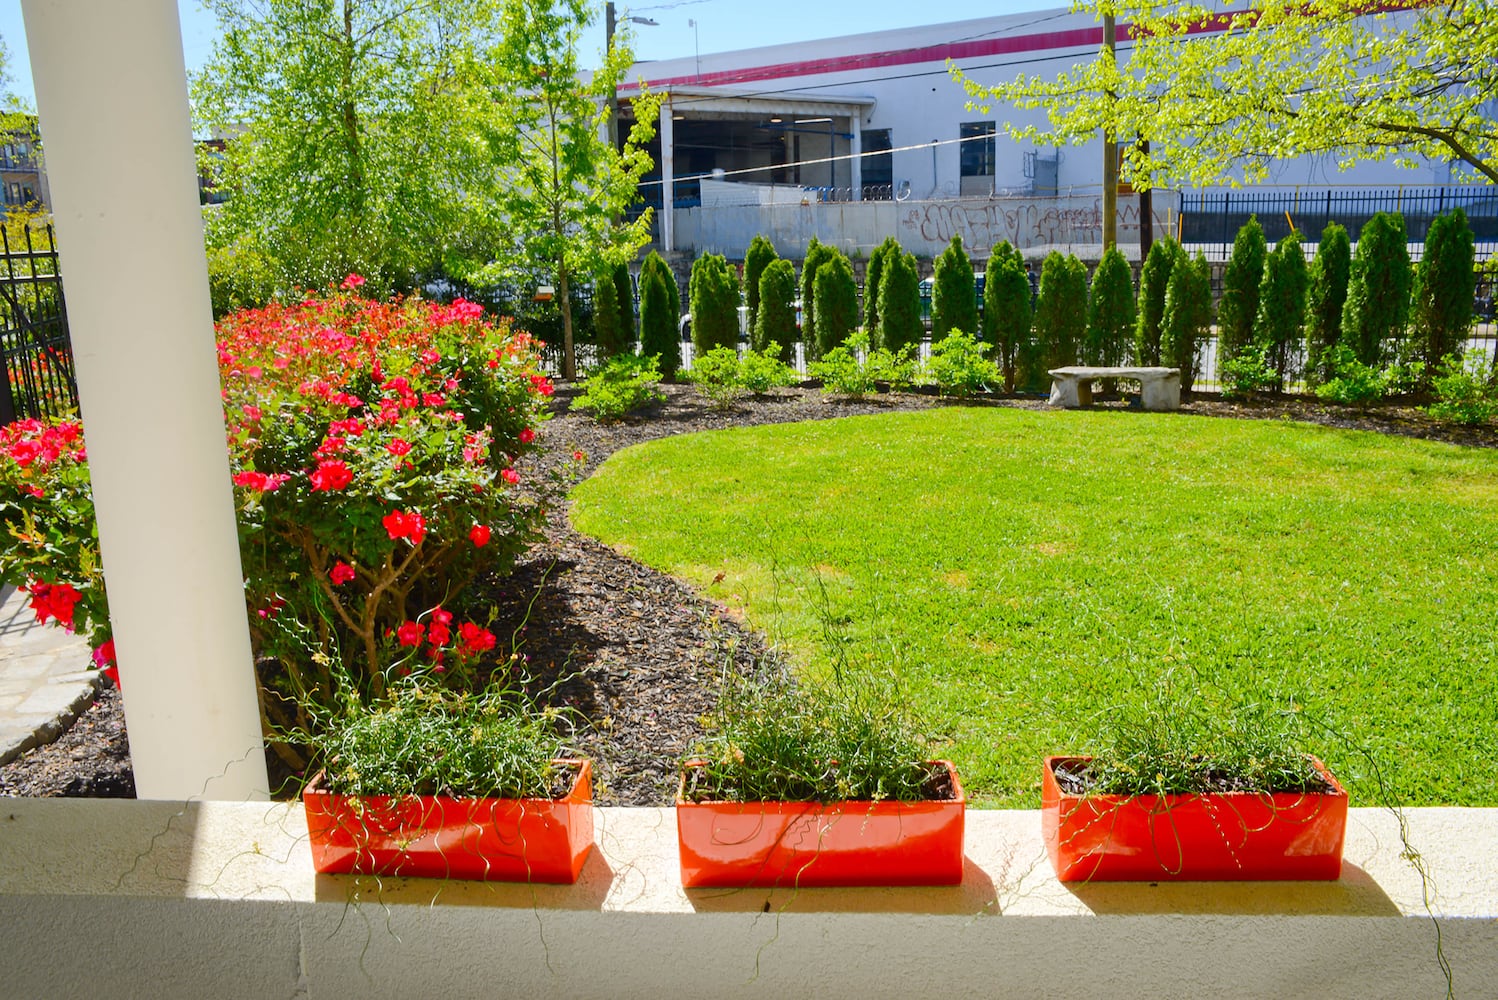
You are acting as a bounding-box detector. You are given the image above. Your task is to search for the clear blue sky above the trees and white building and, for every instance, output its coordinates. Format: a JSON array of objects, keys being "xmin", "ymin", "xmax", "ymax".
[{"xmin": 0, "ymin": 0, "xmax": 1067, "ymax": 103}]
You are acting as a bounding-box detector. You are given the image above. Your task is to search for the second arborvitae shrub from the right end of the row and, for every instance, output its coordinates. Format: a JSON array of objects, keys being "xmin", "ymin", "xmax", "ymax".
[{"xmin": 1342, "ymin": 213, "xmax": 1413, "ymax": 368}]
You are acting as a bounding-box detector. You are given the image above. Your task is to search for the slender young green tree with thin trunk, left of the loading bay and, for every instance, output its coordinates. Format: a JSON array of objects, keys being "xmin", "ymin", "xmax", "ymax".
[{"xmin": 485, "ymin": 0, "xmax": 665, "ymax": 379}]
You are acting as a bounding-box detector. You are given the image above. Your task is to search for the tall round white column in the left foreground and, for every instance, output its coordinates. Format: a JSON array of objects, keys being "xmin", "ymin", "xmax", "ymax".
[{"xmin": 22, "ymin": 0, "xmax": 267, "ymax": 799}]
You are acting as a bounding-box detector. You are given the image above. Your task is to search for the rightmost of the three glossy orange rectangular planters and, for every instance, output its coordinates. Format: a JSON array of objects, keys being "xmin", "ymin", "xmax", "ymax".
[{"xmin": 1041, "ymin": 757, "xmax": 1347, "ymax": 882}]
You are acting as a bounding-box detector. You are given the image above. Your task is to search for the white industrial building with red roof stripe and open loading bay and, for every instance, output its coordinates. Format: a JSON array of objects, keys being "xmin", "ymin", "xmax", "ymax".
[{"xmin": 622, "ymin": 9, "xmax": 1486, "ymax": 256}]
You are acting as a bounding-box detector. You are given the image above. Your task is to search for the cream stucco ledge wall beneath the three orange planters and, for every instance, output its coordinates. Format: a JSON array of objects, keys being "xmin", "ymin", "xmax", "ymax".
[{"xmin": 0, "ymin": 799, "xmax": 1498, "ymax": 1000}]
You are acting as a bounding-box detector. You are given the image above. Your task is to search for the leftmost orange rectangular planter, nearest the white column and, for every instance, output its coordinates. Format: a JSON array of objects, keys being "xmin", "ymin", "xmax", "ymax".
[{"xmin": 303, "ymin": 759, "xmax": 593, "ymax": 882}]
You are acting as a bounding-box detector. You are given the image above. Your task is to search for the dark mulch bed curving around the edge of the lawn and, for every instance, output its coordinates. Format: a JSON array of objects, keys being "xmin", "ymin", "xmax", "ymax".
[{"xmin": 0, "ymin": 386, "xmax": 1498, "ymax": 805}]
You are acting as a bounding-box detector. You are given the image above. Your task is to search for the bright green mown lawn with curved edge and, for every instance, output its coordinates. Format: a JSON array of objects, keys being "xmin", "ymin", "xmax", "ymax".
[{"xmin": 574, "ymin": 409, "xmax": 1498, "ymax": 805}]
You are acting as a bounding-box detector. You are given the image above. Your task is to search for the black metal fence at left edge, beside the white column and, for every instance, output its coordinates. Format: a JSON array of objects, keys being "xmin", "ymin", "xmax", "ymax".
[{"xmin": 0, "ymin": 226, "xmax": 78, "ymax": 425}]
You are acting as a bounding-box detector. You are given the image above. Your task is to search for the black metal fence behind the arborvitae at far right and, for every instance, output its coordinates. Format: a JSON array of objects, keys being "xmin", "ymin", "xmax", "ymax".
[{"xmin": 1180, "ymin": 186, "xmax": 1498, "ymax": 260}]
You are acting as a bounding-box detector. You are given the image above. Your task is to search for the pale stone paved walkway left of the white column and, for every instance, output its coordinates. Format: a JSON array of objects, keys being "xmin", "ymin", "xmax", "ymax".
[{"xmin": 0, "ymin": 577, "xmax": 102, "ymax": 763}]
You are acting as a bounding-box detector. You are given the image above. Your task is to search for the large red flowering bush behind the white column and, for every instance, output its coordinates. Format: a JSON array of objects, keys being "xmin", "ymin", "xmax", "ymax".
[{"xmin": 0, "ymin": 278, "xmax": 551, "ymax": 704}]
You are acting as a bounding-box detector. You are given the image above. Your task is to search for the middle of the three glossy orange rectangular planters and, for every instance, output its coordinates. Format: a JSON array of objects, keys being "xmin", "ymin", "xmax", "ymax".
[{"xmin": 676, "ymin": 760, "xmax": 968, "ymax": 888}]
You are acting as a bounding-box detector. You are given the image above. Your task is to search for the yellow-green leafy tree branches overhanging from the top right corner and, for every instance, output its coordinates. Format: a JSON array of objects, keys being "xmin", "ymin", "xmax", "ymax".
[{"xmin": 954, "ymin": 0, "xmax": 1498, "ymax": 189}]
